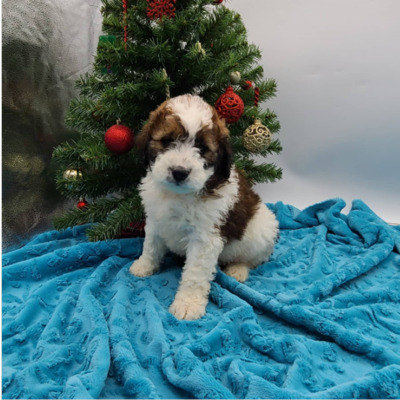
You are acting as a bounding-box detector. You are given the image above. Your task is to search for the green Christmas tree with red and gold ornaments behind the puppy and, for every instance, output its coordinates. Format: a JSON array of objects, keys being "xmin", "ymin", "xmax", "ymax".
[{"xmin": 53, "ymin": 0, "xmax": 282, "ymax": 240}]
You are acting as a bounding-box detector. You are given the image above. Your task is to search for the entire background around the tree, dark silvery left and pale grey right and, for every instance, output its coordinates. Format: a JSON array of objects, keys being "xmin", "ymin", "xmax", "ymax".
[{"xmin": 2, "ymin": 0, "xmax": 400, "ymax": 247}]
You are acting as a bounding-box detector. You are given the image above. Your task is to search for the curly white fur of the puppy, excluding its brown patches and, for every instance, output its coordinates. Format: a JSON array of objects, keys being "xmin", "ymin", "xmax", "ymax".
[{"xmin": 130, "ymin": 96, "xmax": 278, "ymax": 320}]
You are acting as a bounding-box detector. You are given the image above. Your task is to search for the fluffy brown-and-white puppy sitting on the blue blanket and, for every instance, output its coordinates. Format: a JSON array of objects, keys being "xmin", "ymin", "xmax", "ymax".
[{"xmin": 130, "ymin": 95, "xmax": 278, "ymax": 320}]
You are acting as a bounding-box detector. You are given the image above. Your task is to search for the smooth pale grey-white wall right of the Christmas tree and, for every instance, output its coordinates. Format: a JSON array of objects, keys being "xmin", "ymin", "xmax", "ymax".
[{"xmin": 226, "ymin": 0, "xmax": 400, "ymax": 223}]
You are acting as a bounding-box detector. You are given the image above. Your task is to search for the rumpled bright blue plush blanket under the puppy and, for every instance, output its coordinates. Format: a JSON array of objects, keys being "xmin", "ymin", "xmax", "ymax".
[{"xmin": 3, "ymin": 199, "xmax": 400, "ymax": 399}]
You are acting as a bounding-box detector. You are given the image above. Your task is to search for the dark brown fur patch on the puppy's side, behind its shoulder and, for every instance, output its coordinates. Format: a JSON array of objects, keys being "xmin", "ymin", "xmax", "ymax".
[{"xmin": 220, "ymin": 171, "xmax": 261, "ymax": 242}]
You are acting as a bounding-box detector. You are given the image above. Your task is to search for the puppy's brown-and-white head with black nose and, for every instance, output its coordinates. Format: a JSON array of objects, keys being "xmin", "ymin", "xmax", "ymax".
[{"xmin": 137, "ymin": 95, "xmax": 232, "ymax": 194}]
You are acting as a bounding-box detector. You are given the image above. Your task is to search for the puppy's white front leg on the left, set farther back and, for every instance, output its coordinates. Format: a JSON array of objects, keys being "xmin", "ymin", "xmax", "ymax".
[{"xmin": 129, "ymin": 222, "xmax": 167, "ymax": 277}]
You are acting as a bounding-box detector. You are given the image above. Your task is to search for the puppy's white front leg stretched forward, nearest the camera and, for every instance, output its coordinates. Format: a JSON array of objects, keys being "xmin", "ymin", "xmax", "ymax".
[{"xmin": 169, "ymin": 235, "xmax": 223, "ymax": 320}]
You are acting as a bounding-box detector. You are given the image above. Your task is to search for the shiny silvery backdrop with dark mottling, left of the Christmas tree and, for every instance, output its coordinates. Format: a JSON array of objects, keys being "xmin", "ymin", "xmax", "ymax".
[{"xmin": 2, "ymin": 0, "xmax": 101, "ymax": 249}]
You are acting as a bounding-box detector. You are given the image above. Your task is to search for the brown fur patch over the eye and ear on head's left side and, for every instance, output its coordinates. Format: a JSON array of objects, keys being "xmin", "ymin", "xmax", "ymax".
[{"xmin": 136, "ymin": 100, "xmax": 187, "ymax": 168}]
